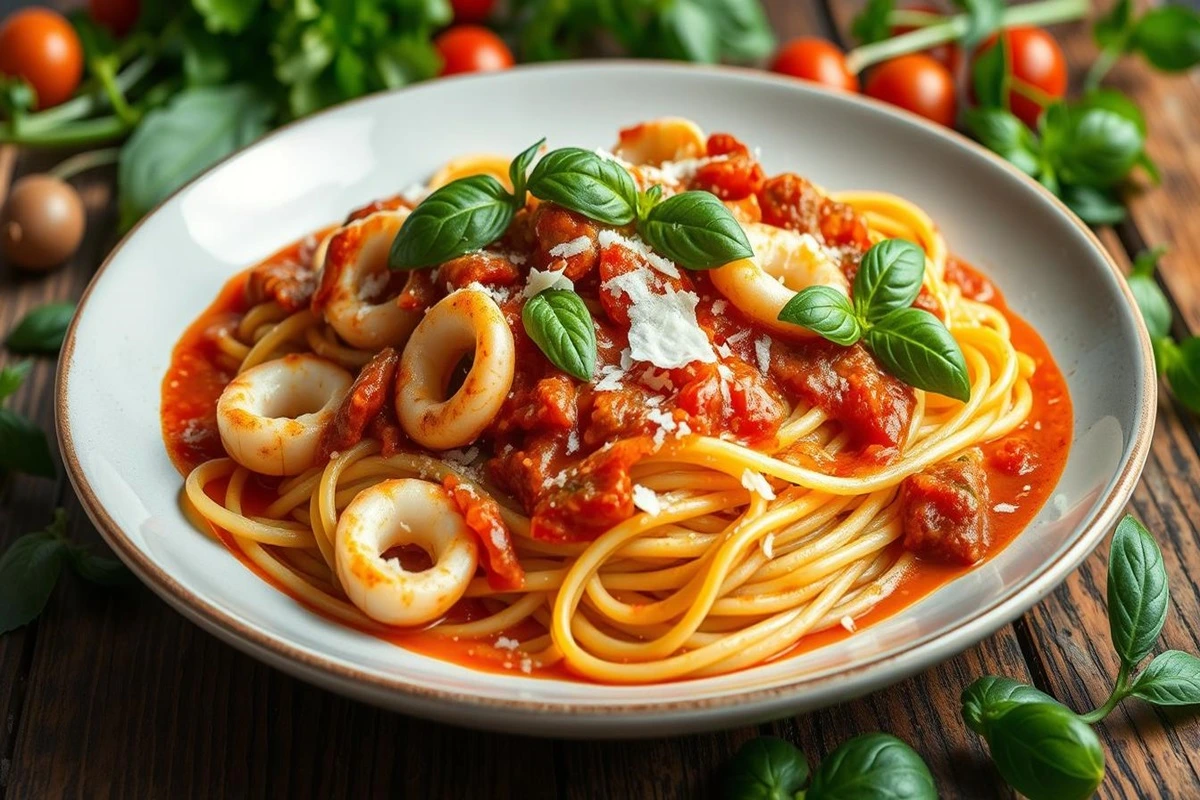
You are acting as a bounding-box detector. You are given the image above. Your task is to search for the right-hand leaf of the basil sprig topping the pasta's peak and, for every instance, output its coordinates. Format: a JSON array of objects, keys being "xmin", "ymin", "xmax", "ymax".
[{"xmin": 637, "ymin": 192, "xmax": 754, "ymax": 270}]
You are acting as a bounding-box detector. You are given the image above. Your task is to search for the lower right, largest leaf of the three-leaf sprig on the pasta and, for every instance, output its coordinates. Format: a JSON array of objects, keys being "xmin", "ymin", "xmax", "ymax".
[{"xmin": 865, "ymin": 308, "xmax": 971, "ymax": 402}]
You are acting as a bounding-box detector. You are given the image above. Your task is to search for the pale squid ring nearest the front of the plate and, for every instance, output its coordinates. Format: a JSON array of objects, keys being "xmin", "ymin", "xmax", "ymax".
[{"xmin": 335, "ymin": 479, "xmax": 479, "ymax": 626}]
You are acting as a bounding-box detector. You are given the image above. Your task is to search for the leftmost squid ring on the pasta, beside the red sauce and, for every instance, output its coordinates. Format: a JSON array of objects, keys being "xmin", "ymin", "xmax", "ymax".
[{"xmin": 217, "ymin": 354, "xmax": 354, "ymax": 475}]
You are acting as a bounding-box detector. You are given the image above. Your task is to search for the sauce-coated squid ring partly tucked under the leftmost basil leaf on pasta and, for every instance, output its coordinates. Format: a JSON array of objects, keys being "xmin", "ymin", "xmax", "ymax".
[{"xmin": 312, "ymin": 209, "xmax": 420, "ymax": 350}]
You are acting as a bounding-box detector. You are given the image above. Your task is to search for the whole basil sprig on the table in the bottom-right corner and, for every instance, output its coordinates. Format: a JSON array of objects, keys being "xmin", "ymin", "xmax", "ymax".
[{"xmin": 962, "ymin": 516, "xmax": 1200, "ymax": 800}]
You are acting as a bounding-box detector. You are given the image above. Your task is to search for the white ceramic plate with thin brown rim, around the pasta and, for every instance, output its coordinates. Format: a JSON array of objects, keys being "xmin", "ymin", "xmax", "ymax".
[{"xmin": 58, "ymin": 62, "xmax": 1156, "ymax": 736}]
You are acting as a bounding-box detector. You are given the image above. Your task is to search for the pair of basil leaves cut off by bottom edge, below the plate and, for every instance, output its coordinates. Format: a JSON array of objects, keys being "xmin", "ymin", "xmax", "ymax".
[{"xmin": 721, "ymin": 733, "xmax": 937, "ymax": 800}]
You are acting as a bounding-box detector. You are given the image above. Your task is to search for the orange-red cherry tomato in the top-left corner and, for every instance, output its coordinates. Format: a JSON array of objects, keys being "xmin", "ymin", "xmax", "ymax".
[{"xmin": 0, "ymin": 7, "xmax": 83, "ymax": 108}]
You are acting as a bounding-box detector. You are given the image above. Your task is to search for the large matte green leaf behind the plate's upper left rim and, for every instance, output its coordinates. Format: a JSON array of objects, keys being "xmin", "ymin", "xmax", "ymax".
[{"xmin": 116, "ymin": 84, "xmax": 275, "ymax": 228}]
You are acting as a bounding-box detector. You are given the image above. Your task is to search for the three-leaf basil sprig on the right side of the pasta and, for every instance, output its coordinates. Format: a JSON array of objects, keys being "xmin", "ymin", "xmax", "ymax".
[{"xmin": 779, "ymin": 239, "xmax": 971, "ymax": 402}]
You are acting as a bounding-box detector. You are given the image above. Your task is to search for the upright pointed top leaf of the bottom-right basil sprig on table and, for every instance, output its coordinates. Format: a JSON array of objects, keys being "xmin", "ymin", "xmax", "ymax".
[{"xmin": 1108, "ymin": 515, "xmax": 1170, "ymax": 669}]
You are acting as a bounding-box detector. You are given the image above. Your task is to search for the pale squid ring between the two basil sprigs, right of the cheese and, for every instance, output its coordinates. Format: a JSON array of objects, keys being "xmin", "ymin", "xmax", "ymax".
[{"xmin": 709, "ymin": 223, "xmax": 850, "ymax": 338}]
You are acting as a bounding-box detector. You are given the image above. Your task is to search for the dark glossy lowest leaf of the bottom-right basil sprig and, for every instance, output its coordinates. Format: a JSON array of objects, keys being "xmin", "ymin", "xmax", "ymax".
[{"xmin": 985, "ymin": 703, "xmax": 1104, "ymax": 800}]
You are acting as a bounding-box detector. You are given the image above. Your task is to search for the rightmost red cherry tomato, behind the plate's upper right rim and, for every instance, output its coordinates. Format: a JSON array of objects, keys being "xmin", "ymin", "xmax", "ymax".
[{"xmin": 974, "ymin": 28, "xmax": 1067, "ymax": 127}]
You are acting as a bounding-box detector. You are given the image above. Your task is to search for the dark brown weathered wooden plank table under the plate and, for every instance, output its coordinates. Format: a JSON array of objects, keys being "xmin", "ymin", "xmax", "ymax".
[{"xmin": 0, "ymin": 0, "xmax": 1200, "ymax": 800}]
